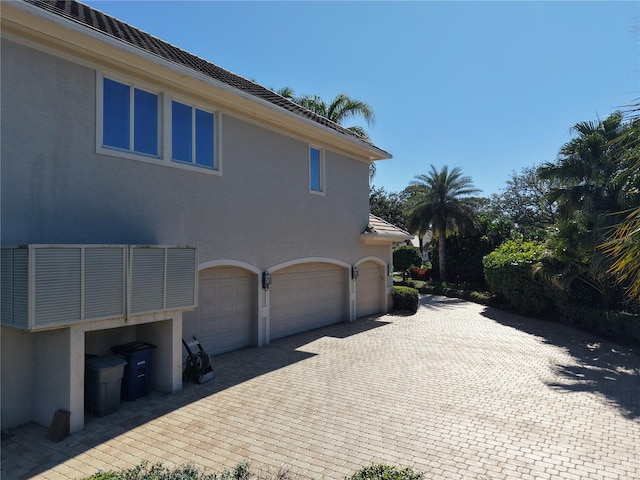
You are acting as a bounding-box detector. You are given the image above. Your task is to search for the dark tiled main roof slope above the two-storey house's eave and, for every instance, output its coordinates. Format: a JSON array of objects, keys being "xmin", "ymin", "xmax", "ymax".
[{"xmin": 23, "ymin": 0, "xmax": 391, "ymax": 158}]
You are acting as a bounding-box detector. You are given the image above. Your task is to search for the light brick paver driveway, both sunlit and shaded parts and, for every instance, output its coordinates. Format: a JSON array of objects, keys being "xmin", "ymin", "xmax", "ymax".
[{"xmin": 2, "ymin": 297, "xmax": 640, "ymax": 480}]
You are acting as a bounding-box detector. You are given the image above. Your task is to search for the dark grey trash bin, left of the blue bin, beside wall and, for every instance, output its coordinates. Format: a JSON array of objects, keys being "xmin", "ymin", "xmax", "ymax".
[{"xmin": 84, "ymin": 355, "xmax": 127, "ymax": 417}]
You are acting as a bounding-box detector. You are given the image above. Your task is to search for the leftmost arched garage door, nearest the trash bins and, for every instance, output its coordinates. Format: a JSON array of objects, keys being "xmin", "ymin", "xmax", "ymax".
[{"xmin": 182, "ymin": 267, "xmax": 257, "ymax": 355}]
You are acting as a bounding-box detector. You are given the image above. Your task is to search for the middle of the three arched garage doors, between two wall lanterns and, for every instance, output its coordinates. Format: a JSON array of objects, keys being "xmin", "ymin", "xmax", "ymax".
[{"xmin": 269, "ymin": 263, "xmax": 349, "ymax": 340}]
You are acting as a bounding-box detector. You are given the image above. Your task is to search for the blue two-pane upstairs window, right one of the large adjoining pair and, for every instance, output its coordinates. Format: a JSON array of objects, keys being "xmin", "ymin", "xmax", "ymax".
[{"xmin": 171, "ymin": 101, "xmax": 216, "ymax": 169}]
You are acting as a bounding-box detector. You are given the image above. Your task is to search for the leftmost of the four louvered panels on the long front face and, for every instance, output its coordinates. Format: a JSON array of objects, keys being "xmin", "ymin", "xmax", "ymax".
[{"xmin": 34, "ymin": 248, "xmax": 82, "ymax": 326}]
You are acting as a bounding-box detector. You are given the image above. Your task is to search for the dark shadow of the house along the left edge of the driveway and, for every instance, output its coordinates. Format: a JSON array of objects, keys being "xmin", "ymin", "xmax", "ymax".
[{"xmin": 0, "ymin": 315, "xmax": 389, "ymax": 480}]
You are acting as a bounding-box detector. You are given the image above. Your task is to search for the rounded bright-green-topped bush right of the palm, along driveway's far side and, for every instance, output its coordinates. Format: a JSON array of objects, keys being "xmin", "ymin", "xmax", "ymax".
[{"xmin": 482, "ymin": 239, "xmax": 557, "ymax": 316}]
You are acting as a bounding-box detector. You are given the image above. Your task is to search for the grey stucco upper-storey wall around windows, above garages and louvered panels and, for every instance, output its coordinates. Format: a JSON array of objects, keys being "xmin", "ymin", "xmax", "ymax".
[{"xmin": 1, "ymin": 36, "xmax": 387, "ymax": 268}]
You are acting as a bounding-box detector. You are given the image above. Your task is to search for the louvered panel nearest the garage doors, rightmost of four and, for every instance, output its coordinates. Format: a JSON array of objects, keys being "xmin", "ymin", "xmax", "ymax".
[{"xmin": 165, "ymin": 248, "xmax": 197, "ymax": 309}]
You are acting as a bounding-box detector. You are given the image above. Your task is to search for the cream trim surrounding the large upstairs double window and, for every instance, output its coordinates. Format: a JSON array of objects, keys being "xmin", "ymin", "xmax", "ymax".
[{"xmin": 96, "ymin": 70, "xmax": 222, "ymax": 176}]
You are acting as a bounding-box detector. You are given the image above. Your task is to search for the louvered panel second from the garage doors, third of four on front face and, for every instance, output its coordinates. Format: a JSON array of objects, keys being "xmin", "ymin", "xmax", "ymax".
[{"xmin": 131, "ymin": 248, "xmax": 165, "ymax": 313}]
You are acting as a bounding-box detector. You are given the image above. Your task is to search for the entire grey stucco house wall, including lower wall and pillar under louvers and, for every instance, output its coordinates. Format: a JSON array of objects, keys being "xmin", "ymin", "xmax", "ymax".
[{"xmin": 0, "ymin": 35, "xmax": 391, "ymax": 431}]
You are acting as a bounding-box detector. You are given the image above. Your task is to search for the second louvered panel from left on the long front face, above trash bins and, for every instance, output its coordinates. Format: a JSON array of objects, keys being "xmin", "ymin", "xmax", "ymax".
[{"xmin": 84, "ymin": 247, "xmax": 125, "ymax": 320}]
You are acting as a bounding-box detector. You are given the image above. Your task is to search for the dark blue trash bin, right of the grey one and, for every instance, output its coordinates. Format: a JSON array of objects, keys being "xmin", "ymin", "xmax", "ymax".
[{"xmin": 111, "ymin": 342, "xmax": 156, "ymax": 400}]
